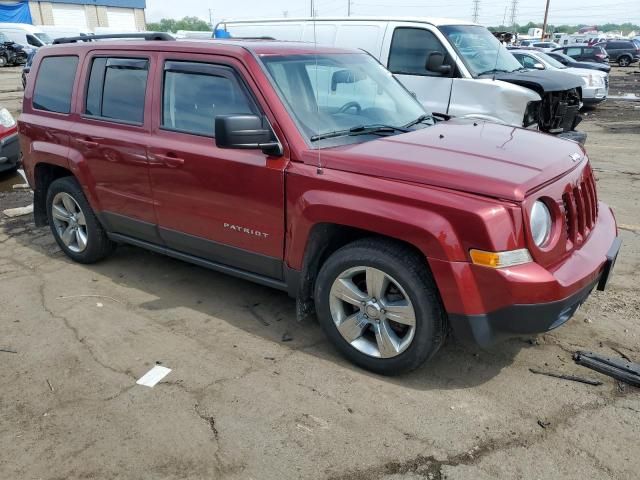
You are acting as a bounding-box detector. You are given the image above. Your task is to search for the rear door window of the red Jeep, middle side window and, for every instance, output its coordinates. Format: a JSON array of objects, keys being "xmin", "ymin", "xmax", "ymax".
[{"xmin": 85, "ymin": 57, "xmax": 149, "ymax": 124}]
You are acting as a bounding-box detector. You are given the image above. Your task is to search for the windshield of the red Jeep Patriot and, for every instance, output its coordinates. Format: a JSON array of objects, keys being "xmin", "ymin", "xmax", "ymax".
[{"xmin": 262, "ymin": 54, "xmax": 425, "ymax": 144}]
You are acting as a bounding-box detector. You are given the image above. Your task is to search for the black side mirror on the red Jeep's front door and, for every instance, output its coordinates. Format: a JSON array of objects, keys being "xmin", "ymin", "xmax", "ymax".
[{"xmin": 215, "ymin": 115, "xmax": 283, "ymax": 156}]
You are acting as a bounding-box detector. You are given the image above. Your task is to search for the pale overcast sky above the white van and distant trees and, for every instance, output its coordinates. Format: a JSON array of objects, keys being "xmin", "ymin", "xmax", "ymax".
[{"xmin": 147, "ymin": 0, "xmax": 640, "ymax": 26}]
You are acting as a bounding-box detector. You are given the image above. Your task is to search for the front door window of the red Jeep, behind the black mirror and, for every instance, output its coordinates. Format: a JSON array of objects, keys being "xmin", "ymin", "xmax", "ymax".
[{"xmin": 162, "ymin": 61, "xmax": 257, "ymax": 137}]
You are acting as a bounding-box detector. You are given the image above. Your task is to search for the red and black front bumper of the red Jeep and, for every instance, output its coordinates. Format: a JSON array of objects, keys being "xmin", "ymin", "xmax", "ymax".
[{"xmin": 429, "ymin": 203, "xmax": 620, "ymax": 346}]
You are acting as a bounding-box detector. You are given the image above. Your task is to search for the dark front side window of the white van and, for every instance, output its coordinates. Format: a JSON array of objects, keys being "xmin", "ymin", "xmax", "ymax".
[{"xmin": 389, "ymin": 28, "xmax": 447, "ymax": 77}]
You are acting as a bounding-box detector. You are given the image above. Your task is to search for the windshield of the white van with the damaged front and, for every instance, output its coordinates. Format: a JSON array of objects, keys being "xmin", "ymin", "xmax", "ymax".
[{"xmin": 440, "ymin": 25, "xmax": 522, "ymax": 77}]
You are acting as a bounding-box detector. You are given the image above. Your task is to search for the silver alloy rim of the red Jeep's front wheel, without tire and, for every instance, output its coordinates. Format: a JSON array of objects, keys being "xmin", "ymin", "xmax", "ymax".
[{"xmin": 329, "ymin": 266, "xmax": 416, "ymax": 358}]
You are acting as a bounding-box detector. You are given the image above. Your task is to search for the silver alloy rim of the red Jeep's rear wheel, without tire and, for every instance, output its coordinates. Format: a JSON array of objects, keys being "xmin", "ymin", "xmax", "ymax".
[{"xmin": 51, "ymin": 192, "xmax": 89, "ymax": 253}]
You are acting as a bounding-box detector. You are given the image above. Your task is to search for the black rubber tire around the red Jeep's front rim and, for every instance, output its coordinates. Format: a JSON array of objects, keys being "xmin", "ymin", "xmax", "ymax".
[{"xmin": 315, "ymin": 238, "xmax": 447, "ymax": 375}]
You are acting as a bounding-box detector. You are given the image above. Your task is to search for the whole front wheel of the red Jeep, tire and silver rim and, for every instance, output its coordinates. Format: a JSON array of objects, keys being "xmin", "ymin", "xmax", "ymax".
[{"xmin": 315, "ymin": 239, "xmax": 446, "ymax": 375}]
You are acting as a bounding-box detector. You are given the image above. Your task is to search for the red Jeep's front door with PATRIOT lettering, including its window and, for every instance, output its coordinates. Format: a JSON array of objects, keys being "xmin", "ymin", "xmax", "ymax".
[{"xmin": 148, "ymin": 54, "xmax": 286, "ymax": 279}]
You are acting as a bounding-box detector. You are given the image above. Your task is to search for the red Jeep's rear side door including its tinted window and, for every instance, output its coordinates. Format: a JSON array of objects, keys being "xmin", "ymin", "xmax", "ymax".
[{"xmin": 71, "ymin": 51, "xmax": 159, "ymax": 242}]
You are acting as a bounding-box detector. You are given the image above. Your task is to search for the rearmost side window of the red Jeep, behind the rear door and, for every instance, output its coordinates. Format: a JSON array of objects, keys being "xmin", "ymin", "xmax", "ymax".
[{"xmin": 33, "ymin": 56, "xmax": 78, "ymax": 113}]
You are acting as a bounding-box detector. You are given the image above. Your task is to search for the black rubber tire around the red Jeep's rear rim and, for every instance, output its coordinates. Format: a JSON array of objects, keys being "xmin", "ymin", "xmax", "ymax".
[{"xmin": 46, "ymin": 177, "xmax": 116, "ymax": 264}]
